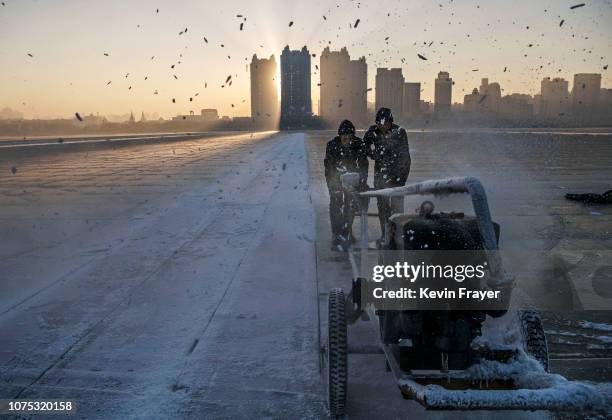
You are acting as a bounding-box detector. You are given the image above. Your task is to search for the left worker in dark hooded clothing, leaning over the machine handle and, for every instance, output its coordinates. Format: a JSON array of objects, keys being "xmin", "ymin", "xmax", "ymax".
[{"xmin": 325, "ymin": 120, "xmax": 368, "ymax": 249}]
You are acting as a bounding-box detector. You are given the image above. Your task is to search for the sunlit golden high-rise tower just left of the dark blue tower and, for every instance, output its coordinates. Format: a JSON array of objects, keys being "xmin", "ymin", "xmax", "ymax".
[{"xmin": 250, "ymin": 54, "xmax": 278, "ymax": 126}]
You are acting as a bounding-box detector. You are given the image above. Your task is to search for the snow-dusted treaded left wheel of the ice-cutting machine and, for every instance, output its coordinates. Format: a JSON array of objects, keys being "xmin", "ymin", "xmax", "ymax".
[{"xmin": 327, "ymin": 289, "xmax": 348, "ymax": 419}]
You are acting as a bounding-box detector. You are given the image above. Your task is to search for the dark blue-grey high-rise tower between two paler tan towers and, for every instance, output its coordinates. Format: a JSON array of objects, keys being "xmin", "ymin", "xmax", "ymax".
[{"xmin": 281, "ymin": 46, "xmax": 312, "ymax": 127}]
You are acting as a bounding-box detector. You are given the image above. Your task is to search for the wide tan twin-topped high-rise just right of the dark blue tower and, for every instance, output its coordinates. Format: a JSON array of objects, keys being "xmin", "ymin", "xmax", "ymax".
[{"xmin": 319, "ymin": 47, "xmax": 368, "ymax": 127}]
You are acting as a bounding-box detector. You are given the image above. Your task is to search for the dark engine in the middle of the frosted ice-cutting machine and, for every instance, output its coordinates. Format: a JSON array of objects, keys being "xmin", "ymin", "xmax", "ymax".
[{"xmin": 377, "ymin": 201, "xmax": 499, "ymax": 370}]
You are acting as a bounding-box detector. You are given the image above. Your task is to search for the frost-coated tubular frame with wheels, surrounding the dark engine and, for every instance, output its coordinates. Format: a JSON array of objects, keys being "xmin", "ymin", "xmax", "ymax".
[{"xmin": 327, "ymin": 173, "xmax": 599, "ymax": 417}]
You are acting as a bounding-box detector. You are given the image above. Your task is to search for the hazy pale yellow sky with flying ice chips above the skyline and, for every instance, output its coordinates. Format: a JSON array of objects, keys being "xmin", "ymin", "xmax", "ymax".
[{"xmin": 0, "ymin": 0, "xmax": 612, "ymax": 118}]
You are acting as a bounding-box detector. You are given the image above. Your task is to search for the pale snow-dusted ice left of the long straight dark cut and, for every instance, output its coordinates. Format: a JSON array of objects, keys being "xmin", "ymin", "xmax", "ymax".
[{"xmin": 0, "ymin": 134, "xmax": 326, "ymax": 419}]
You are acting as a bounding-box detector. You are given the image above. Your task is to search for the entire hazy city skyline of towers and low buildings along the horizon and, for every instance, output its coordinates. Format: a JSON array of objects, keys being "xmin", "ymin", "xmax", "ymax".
[{"xmin": 0, "ymin": 59, "xmax": 612, "ymax": 138}]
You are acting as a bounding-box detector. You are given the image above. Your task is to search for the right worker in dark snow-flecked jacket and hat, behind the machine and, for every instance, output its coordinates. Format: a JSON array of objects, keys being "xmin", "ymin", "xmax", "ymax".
[{"xmin": 363, "ymin": 108, "xmax": 411, "ymax": 239}]
